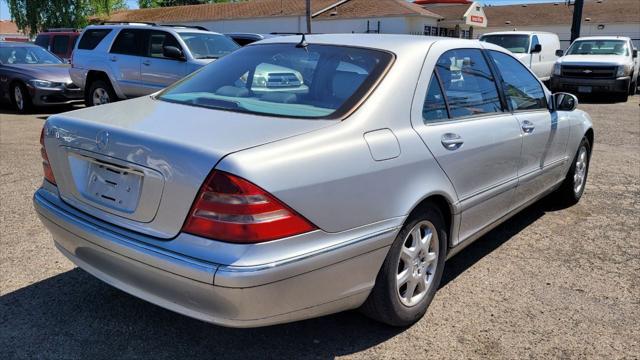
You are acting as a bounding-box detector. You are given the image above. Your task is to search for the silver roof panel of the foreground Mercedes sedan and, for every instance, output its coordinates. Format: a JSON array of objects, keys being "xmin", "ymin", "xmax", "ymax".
[{"xmin": 248, "ymin": 34, "xmax": 442, "ymax": 52}]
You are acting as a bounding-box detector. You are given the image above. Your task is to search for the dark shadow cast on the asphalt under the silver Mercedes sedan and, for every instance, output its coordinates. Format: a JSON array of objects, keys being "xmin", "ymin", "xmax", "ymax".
[{"xmin": 0, "ymin": 200, "xmax": 556, "ymax": 359}]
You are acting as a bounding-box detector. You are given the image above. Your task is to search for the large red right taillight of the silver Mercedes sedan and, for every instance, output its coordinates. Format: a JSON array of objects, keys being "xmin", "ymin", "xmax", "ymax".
[{"xmin": 182, "ymin": 171, "xmax": 316, "ymax": 243}]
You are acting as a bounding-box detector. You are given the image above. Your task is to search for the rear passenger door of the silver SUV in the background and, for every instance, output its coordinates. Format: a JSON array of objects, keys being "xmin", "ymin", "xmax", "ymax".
[{"xmin": 109, "ymin": 29, "xmax": 148, "ymax": 97}]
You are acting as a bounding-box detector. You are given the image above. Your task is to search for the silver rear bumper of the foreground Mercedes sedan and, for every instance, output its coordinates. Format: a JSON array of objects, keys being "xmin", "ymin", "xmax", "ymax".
[{"xmin": 33, "ymin": 189, "xmax": 396, "ymax": 327}]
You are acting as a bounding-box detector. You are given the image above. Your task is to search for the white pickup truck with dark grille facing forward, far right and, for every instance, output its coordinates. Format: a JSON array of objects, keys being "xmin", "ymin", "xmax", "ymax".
[{"xmin": 551, "ymin": 36, "xmax": 640, "ymax": 101}]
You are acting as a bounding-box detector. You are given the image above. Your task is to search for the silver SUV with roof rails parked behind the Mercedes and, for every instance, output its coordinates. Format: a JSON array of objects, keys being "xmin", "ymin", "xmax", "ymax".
[{"xmin": 69, "ymin": 23, "xmax": 239, "ymax": 106}]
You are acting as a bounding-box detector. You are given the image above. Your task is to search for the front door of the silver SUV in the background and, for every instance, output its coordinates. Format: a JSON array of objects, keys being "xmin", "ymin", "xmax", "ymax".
[{"xmin": 141, "ymin": 30, "xmax": 187, "ymax": 94}]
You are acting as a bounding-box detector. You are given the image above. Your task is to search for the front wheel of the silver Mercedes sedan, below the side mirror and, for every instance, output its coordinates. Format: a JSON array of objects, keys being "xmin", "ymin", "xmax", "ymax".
[{"xmin": 554, "ymin": 138, "xmax": 591, "ymax": 206}]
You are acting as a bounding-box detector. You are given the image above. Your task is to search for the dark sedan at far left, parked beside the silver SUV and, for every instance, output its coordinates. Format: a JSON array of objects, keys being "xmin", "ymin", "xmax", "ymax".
[{"xmin": 0, "ymin": 41, "xmax": 83, "ymax": 113}]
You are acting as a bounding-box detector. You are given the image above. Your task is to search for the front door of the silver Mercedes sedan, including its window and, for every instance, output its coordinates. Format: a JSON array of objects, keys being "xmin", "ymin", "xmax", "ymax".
[{"xmin": 488, "ymin": 50, "xmax": 570, "ymax": 207}]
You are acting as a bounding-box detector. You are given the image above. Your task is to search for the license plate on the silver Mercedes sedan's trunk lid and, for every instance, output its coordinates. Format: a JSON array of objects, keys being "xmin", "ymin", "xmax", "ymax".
[{"xmin": 86, "ymin": 162, "xmax": 143, "ymax": 213}]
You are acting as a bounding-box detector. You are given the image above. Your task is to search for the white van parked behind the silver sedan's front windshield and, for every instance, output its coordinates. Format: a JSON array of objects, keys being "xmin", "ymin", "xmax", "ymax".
[{"xmin": 480, "ymin": 31, "xmax": 560, "ymax": 81}]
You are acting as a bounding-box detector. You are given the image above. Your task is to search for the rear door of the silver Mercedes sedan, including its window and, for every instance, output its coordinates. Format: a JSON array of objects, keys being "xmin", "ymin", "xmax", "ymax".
[{"xmin": 412, "ymin": 43, "xmax": 522, "ymax": 241}]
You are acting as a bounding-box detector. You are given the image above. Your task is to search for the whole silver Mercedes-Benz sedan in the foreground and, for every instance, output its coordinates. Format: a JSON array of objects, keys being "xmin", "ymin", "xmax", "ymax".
[{"xmin": 34, "ymin": 34, "xmax": 594, "ymax": 327}]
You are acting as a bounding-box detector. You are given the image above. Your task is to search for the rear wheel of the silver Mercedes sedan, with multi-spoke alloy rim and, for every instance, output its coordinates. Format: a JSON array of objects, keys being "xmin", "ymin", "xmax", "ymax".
[{"xmin": 360, "ymin": 204, "xmax": 447, "ymax": 327}]
